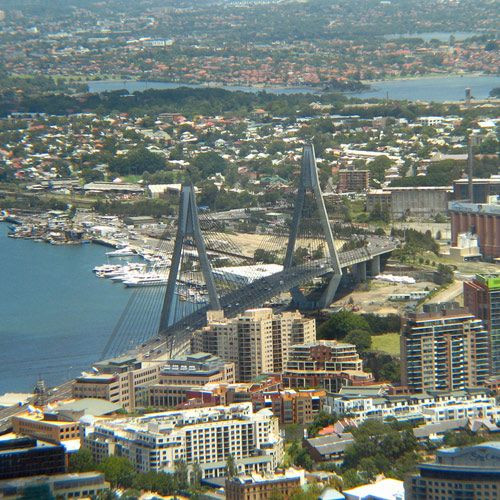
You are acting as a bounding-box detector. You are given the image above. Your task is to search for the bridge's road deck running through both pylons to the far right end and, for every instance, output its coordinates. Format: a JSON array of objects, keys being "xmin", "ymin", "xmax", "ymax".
[{"xmin": 158, "ymin": 237, "xmax": 397, "ymax": 354}]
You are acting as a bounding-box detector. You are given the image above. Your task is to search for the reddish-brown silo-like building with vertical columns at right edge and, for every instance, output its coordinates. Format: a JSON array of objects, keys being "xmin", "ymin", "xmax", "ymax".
[{"xmin": 449, "ymin": 197, "xmax": 500, "ymax": 259}]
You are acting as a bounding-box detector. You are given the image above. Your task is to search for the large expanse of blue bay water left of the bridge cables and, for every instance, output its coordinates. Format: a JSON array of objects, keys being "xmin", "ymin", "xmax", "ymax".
[{"xmin": 0, "ymin": 224, "xmax": 132, "ymax": 394}]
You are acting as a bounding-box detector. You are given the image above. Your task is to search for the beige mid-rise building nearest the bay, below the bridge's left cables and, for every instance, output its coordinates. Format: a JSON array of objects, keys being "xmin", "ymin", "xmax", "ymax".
[{"xmin": 73, "ymin": 357, "xmax": 162, "ymax": 411}]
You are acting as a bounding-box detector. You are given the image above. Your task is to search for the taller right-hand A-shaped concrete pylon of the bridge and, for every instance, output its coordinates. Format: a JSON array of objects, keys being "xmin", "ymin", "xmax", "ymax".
[{"xmin": 284, "ymin": 144, "xmax": 342, "ymax": 308}]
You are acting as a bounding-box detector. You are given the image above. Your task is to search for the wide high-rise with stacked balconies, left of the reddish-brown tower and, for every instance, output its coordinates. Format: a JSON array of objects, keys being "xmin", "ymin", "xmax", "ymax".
[{"xmin": 401, "ymin": 304, "xmax": 490, "ymax": 392}]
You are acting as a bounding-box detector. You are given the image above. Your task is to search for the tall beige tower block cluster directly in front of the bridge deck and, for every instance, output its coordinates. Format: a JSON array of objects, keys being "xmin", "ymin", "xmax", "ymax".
[{"xmin": 192, "ymin": 308, "xmax": 316, "ymax": 382}]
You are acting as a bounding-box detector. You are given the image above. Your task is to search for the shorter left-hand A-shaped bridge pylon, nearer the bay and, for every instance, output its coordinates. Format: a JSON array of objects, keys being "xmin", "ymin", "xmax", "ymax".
[{"xmin": 158, "ymin": 184, "xmax": 221, "ymax": 333}]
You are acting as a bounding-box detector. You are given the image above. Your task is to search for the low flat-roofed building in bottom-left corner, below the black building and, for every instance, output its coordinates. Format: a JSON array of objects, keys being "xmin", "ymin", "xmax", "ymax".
[{"xmin": 0, "ymin": 472, "xmax": 109, "ymax": 500}]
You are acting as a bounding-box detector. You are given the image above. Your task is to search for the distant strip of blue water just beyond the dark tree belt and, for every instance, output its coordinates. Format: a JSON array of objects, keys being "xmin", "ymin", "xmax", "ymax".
[{"xmin": 88, "ymin": 75, "xmax": 500, "ymax": 102}]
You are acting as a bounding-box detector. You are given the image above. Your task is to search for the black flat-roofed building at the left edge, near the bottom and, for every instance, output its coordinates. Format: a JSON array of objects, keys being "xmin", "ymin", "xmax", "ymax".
[{"xmin": 0, "ymin": 434, "xmax": 67, "ymax": 480}]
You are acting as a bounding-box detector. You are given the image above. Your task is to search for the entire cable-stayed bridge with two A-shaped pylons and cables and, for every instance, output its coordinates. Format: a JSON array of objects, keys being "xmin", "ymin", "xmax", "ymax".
[{"xmin": 102, "ymin": 144, "xmax": 397, "ymax": 358}]
